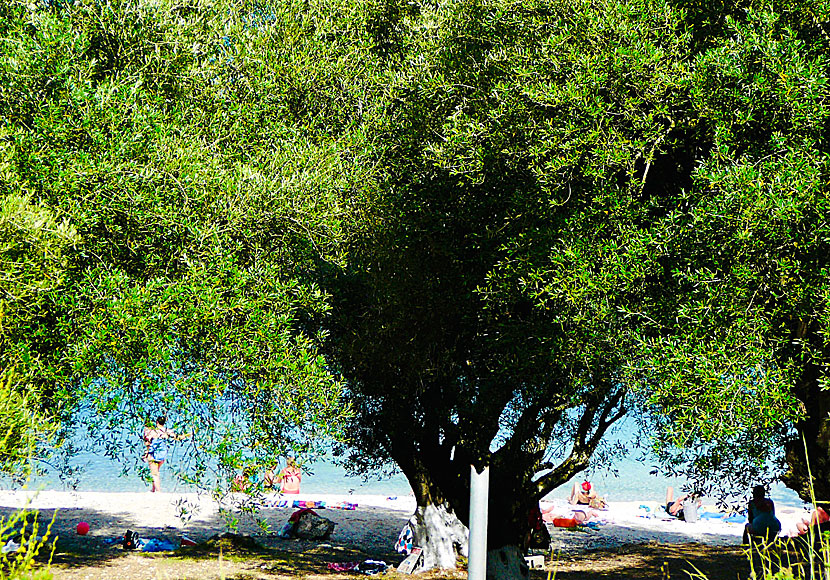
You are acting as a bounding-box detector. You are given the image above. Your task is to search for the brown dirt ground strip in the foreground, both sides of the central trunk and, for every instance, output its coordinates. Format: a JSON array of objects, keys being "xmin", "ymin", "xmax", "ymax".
[{"xmin": 37, "ymin": 537, "xmax": 750, "ymax": 580}]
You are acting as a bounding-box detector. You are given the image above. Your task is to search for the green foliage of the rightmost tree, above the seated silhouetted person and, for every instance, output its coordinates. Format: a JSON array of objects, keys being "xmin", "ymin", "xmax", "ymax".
[{"xmin": 632, "ymin": 3, "xmax": 830, "ymax": 499}]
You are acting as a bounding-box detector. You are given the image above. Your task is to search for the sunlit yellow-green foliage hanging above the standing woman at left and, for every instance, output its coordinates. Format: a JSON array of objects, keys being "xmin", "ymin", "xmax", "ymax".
[{"xmin": 0, "ymin": 0, "xmax": 370, "ymax": 490}]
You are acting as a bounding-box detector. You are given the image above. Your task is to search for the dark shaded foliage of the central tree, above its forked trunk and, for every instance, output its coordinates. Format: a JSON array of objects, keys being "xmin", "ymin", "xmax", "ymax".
[{"xmin": 331, "ymin": 2, "xmax": 685, "ymax": 547}]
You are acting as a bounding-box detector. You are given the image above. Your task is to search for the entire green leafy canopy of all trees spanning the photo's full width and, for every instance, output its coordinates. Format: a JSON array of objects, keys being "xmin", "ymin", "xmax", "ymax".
[{"xmin": 0, "ymin": 0, "xmax": 830, "ymax": 568}]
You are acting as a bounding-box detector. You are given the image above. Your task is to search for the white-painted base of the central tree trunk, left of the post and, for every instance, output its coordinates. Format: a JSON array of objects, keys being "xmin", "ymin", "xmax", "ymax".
[{"xmin": 409, "ymin": 503, "xmax": 469, "ymax": 572}]
